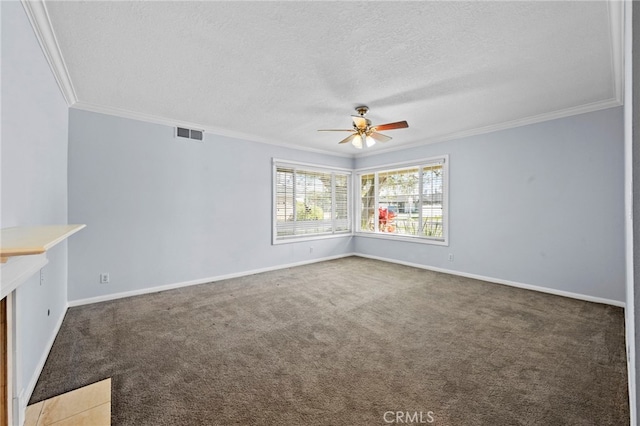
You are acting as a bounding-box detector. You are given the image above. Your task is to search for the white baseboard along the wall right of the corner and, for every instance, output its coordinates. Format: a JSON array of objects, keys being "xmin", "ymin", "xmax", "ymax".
[{"xmin": 355, "ymin": 253, "xmax": 625, "ymax": 308}]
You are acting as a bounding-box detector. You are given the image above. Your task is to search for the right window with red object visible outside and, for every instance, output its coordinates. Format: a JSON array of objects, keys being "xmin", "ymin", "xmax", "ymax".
[{"xmin": 357, "ymin": 156, "xmax": 448, "ymax": 244}]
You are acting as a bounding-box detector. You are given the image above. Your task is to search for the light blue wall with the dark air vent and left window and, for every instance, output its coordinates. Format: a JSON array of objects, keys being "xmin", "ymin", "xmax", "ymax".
[{"xmin": 69, "ymin": 109, "xmax": 353, "ymax": 301}]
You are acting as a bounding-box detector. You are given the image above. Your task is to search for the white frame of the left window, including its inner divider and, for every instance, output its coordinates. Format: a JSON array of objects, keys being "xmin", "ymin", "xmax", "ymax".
[{"xmin": 271, "ymin": 158, "xmax": 354, "ymax": 245}]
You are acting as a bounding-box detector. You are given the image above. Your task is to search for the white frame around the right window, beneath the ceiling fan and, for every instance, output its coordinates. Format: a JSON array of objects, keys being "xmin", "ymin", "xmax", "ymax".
[{"xmin": 352, "ymin": 154, "xmax": 450, "ymax": 246}]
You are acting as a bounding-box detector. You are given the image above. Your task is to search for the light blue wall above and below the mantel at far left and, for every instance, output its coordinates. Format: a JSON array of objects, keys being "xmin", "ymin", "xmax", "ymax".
[{"xmin": 0, "ymin": 1, "xmax": 68, "ymax": 410}]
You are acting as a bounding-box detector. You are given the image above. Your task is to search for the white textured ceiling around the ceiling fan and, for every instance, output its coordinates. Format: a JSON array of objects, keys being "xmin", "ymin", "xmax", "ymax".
[{"xmin": 41, "ymin": 1, "xmax": 622, "ymax": 155}]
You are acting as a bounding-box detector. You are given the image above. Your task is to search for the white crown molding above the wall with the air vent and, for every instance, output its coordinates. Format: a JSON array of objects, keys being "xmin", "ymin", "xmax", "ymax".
[{"xmin": 71, "ymin": 101, "xmax": 353, "ymax": 158}]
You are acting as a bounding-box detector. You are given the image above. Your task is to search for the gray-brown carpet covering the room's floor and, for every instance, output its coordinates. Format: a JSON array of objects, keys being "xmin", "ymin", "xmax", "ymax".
[{"xmin": 31, "ymin": 257, "xmax": 629, "ymax": 426}]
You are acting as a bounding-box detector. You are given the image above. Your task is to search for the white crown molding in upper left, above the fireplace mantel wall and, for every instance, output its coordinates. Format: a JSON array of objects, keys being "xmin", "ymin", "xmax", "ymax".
[{"xmin": 21, "ymin": 0, "xmax": 78, "ymax": 106}]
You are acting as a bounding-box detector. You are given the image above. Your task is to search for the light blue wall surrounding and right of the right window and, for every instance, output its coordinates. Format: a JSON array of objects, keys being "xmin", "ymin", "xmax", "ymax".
[{"xmin": 355, "ymin": 107, "xmax": 625, "ymax": 302}]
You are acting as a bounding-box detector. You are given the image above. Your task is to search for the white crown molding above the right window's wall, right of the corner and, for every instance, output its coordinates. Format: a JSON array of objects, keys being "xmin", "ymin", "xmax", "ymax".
[{"xmin": 356, "ymin": 98, "xmax": 622, "ymax": 158}]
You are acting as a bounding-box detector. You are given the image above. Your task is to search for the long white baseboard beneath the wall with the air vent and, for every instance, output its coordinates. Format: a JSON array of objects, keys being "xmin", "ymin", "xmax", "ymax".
[{"xmin": 69, "ymin": 253, "xmax": 356, "ymax": 307}]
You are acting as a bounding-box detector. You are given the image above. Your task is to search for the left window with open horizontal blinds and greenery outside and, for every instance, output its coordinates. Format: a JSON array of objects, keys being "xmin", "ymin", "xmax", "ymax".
[{"xmin": 273, "ymin": 160, "xmax": 351, "ymax": 244}]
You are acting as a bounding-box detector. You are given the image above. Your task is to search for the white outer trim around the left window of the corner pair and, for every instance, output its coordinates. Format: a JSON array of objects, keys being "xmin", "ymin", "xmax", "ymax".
[{"xmin": 271, "ymin": 158, "xmax": 354, "ymax": 245}]
